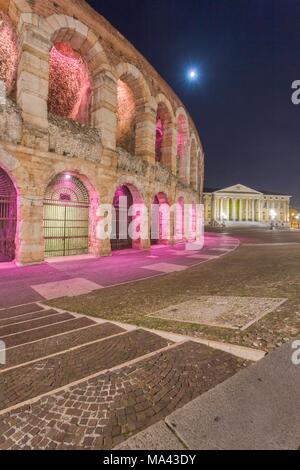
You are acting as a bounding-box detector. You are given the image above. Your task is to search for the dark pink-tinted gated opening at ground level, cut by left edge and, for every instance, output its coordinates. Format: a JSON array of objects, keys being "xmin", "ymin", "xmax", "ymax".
[{"xmin": 0, "ymin": 167, "xmax": 17, "ymax": 262}]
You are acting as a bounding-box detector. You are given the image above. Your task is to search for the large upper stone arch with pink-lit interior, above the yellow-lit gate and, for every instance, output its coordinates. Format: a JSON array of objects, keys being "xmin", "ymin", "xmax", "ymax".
[{"xmin": 46, "ymin": 15, "xmax": 107, "ymax": 124}]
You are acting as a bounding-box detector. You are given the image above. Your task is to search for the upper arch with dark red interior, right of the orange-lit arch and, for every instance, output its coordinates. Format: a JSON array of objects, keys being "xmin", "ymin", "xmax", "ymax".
[{"xmin": 155, "ymin": 93, "xmax": 175, "ymax": 169}]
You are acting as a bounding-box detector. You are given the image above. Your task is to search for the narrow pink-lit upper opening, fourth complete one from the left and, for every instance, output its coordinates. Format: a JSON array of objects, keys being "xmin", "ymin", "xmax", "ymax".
[{"xmin": 177, "ymin": 114, "xmax": 189, "ymax": 183}]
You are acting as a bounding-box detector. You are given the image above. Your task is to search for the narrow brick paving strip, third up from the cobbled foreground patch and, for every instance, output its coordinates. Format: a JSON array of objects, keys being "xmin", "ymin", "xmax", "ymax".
[{"xmin": 1, "ymin": 317, "xmax": 95, "ymax": 348}]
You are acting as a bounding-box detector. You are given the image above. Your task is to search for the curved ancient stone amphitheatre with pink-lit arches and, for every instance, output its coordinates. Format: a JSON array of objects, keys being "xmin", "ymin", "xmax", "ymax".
[{"xmin": 0, "ymin": 0, "xmax": 204, "ymax": 264}]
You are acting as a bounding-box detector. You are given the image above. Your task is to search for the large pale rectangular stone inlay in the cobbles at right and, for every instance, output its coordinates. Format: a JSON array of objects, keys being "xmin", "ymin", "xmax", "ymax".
[{"xmin": 150, "ymin": 296, "xmax": 286, "ymax": 330}]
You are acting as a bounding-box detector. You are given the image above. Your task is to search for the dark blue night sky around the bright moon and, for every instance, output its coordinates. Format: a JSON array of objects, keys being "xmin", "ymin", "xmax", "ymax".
[{"xmin": 88, "ymin": 0, "xmax": 300, "ymax": 208}]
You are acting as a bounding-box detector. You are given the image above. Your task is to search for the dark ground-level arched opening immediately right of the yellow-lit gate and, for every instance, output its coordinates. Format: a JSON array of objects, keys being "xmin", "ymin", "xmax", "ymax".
[{"xmin": 111, "ymin": 184, "xmax": 143, "ymax": 251}]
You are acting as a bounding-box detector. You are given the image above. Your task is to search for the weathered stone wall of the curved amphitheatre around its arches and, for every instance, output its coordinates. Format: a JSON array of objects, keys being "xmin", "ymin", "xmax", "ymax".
[{"xmin": 0, "ymin": 0, "xmax": 204, "ymax": 264}]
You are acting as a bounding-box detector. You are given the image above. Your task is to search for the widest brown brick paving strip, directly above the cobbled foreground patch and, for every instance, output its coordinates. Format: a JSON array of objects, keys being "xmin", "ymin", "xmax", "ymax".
[{"xmin": 0, "ymin": 330, "xmax": 170, "ymax": 410}]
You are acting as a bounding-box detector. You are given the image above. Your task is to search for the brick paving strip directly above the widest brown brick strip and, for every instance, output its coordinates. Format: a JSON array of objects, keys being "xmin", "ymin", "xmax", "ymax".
[{"xmin": 0, "ymin": 323, "xmax": 125, "ymax": 372}]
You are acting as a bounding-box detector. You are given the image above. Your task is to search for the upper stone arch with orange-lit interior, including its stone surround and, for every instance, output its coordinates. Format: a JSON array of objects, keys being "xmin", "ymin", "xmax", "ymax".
[{"xmin": 115, "ymin": 63, "xmax": 151, "ymax": 157}]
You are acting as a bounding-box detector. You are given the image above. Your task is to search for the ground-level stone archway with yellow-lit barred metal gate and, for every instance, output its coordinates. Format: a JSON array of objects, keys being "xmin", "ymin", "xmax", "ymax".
[{"xmin": 44, "ymin": 170, "xmax": 99, "ymax": 256}]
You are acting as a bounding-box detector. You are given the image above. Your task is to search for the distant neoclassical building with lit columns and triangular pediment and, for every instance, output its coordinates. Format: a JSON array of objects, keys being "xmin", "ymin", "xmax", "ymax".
[{"xmin": 204, "ymin": 184, "xmax": 291, "ymax": 226}]
